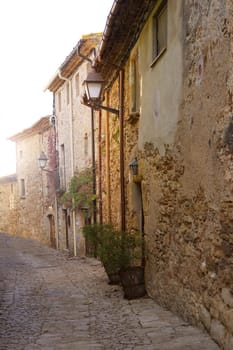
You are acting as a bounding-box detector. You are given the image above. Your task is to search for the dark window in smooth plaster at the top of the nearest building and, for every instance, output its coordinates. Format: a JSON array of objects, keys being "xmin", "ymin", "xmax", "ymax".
[{"xmin": 153, "ymin": 1, "xmax": 167, "ymax": 60}]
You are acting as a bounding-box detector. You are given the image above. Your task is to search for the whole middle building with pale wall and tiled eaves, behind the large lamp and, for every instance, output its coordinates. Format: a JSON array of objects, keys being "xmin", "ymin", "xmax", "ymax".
[{"xmin": 46, "ymin": 34, "xmax": 101, "ymax": 255}]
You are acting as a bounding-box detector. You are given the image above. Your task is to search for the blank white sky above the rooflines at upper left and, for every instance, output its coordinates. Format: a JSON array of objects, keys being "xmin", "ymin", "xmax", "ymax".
[{"xmin": 0, "ymin": 0, "xmax": 114, "ymax": 176}]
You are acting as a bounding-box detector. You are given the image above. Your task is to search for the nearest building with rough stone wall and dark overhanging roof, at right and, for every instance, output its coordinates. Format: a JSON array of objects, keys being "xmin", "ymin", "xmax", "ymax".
[{"xmin": 86, "ymin": 0, "xmax": 233, "ymax": 350}]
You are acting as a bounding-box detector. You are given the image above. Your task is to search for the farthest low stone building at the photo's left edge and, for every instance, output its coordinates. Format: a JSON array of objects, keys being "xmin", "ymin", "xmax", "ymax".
[{"xmin": 0, "ymin": 174, "xmax": 18, "ymax": 234}]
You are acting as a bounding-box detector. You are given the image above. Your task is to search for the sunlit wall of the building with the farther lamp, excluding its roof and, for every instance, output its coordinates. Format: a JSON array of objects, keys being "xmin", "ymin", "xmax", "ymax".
[{"xmin": 16, "ymin": 129, "xmax": 55, "ymax": 245}]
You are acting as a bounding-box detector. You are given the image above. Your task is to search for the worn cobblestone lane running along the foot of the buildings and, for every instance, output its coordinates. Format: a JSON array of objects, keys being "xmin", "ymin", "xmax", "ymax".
[{"xmin": 0, "ymin": 234, "xmax": 219, "ymax": 350}]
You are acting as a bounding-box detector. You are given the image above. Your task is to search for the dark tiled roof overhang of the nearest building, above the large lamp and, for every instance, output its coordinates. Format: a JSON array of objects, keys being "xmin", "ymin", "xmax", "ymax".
[{"xmin": 95, "ymin": 0, "xmax": 158, "ymax": 86}]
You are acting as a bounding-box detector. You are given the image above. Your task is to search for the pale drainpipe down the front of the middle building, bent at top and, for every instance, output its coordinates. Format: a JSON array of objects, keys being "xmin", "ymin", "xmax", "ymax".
[{"xmin": 58, "ymin": 70, "xmax": 77, "ymax": 256}]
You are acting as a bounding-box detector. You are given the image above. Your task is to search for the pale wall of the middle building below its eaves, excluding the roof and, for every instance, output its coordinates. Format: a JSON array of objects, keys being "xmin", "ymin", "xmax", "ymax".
[{"xmin": 55, "ymin": 54, "xmax": 98, "ymax": 256}]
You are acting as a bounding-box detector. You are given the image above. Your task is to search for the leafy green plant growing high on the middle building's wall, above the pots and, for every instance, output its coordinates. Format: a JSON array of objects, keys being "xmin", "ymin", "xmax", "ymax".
[{"xmin": 60, "ymin": 168, "xmax": 96, "ymax": 210}]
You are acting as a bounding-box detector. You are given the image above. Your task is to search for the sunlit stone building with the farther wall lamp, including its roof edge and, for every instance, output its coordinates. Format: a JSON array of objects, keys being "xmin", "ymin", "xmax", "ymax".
[{"xmin": 7, "ymin": 116, "xmax": 58, "ymax": 248}]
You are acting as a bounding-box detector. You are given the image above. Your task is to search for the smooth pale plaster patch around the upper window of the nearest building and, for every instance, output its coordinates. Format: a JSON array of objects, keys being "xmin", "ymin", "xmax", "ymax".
[{"xmin": 137, "ymin": 1, "xmax": 183, "ymax": 152}]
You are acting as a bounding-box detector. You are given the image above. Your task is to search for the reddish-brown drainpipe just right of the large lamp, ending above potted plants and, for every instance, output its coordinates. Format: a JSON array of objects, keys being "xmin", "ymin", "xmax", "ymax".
[{"xmin": 119, "ymin": 69, "xmax": 126, "ymax": 231}]
